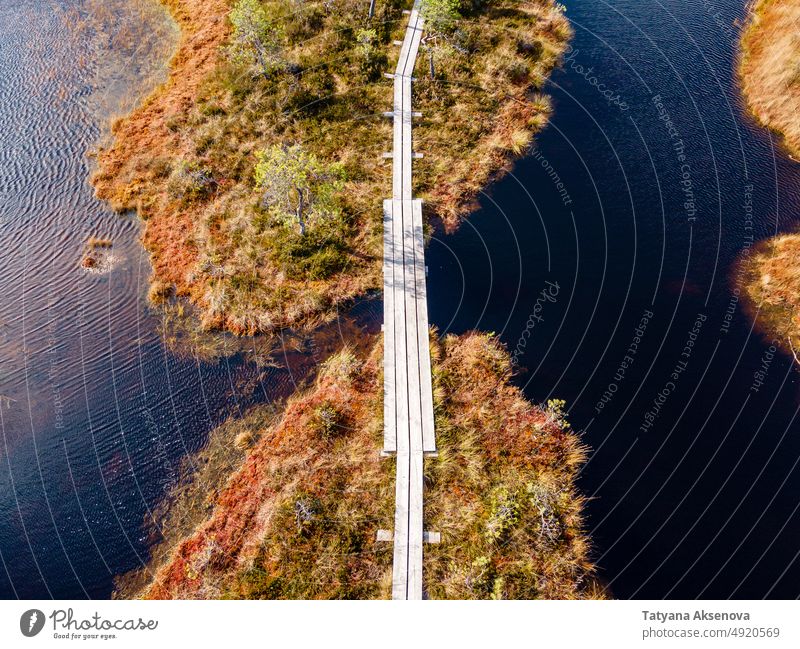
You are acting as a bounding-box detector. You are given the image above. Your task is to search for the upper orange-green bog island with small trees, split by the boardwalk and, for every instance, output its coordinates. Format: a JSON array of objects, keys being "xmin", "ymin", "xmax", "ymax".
[{"xmin": 94, "ymin": 0, "xmax": 570, "ymax": 333}]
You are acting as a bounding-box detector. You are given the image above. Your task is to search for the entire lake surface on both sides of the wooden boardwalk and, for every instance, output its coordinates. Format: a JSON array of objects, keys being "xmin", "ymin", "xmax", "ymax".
[{"xmin": 0, "ymin": 0, "xmax": 800, "ymax": 598}]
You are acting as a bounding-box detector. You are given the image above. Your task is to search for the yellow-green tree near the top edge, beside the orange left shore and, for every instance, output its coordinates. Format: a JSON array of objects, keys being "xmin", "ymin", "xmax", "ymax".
[{"xmin": 228, "ymin": 0, "xmax": 286, "ymax": 78}]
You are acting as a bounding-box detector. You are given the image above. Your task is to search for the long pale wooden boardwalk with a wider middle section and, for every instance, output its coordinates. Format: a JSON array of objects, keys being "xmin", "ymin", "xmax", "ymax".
[{"xmin": 383, "ymin": 0, "xmax": 436, "ymax": 599}]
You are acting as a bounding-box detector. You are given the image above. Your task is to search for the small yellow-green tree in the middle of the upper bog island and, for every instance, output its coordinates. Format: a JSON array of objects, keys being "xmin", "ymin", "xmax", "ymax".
[{"xmin": 255, "ymin": 144, "xmax": 343, "ymax": 236}]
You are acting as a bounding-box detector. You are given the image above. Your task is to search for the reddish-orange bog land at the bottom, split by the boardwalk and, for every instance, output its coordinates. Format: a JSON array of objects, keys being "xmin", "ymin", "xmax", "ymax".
[{"xmin": 131, "ymin": 334, "xmax": 604, "ymax": 599}]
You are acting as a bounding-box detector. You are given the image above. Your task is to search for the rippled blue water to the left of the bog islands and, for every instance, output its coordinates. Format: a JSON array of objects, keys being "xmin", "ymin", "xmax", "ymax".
[{"xmin": 0, "ymin": 0, "xmax": 380, "ymax": 598}]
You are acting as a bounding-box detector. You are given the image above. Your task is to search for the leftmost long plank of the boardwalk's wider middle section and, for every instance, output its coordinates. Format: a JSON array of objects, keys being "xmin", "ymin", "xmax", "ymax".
[{"xmin": 383, "ymin": 199, "xmax": 397, "ymax": 453}]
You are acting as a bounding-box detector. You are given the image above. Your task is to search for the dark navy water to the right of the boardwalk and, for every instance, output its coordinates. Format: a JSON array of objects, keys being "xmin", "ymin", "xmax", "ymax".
[{"xmin": 428, "ymin": 0, "xmax": 800, "ymax": 598}]
